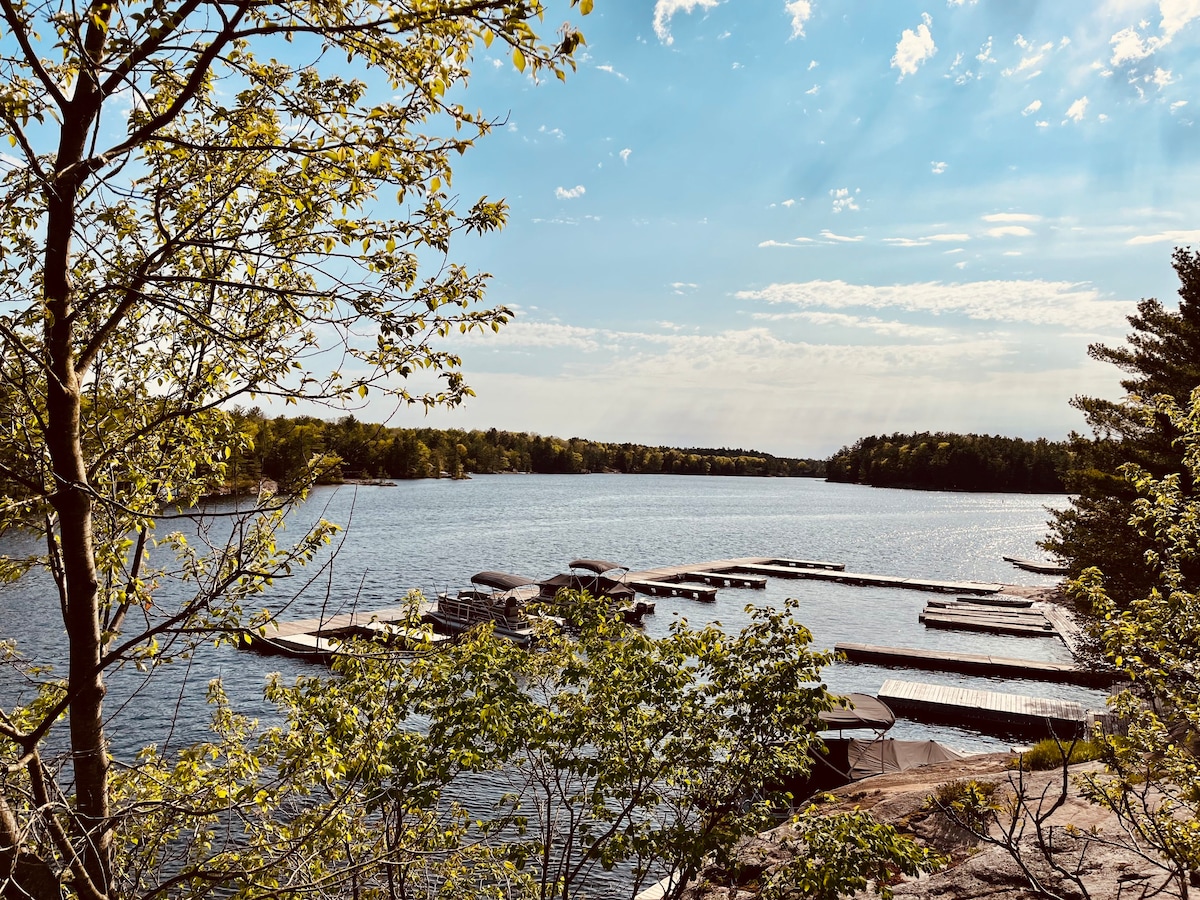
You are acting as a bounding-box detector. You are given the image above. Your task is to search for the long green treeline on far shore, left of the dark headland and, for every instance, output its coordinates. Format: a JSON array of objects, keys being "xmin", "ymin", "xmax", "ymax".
[{"xmin": 225, "ymin": 409, "xmax": 824, "ymax": 486}]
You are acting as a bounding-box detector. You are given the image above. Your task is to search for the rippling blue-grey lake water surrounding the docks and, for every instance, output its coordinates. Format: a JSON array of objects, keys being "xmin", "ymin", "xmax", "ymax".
[{"xmin": 0, "ymin": 474, "xmax": 1103, "ymax": 754}]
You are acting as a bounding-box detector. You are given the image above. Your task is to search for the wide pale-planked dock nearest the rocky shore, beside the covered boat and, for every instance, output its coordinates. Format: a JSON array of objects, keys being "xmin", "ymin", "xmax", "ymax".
[{"xmin": 878, "ymin": 678, "xmax": 1094, "ymax": 739}]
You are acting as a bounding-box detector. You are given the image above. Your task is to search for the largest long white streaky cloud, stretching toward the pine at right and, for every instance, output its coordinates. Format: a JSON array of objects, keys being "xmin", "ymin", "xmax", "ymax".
[{"xmin": 734, "ymin": 280, "xmax": 1134, "ymax": 329}]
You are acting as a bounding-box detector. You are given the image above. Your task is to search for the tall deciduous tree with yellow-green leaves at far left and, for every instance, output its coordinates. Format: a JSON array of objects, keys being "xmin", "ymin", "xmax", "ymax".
[{"xmin": 0, "ymin": 0, "xmax": 592, "ymax": 900}]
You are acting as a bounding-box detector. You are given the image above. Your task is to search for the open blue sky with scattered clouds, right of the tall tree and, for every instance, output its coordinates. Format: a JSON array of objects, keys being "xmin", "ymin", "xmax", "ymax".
[{"xmin": 376, "ymin": 0, "xmax": 1200, "ymax": 456}]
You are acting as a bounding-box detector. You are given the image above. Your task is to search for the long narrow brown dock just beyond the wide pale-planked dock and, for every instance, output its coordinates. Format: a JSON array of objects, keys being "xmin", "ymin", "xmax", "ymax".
[{"xmin": 834, "ymin": 643, "xmax": 1120, "ymax": 688}]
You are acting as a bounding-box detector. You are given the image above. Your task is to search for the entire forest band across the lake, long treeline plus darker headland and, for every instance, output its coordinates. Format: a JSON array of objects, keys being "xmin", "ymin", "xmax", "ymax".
[{"xmin": 228, "ymin": 409, "xmax": 1069, "ymax": 493}]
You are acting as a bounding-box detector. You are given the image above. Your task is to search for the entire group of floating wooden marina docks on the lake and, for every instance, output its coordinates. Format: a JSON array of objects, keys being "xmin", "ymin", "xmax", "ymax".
[{"xmin": 246, "ymin": 557, "xmax": 1114, "ymax": 738}]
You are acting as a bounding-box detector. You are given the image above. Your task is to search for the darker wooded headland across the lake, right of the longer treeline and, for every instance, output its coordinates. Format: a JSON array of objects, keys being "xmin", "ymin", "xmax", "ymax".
[{"xmin": 826, "ymin": 432, "xmax": 1068, "ymax": 493}]
